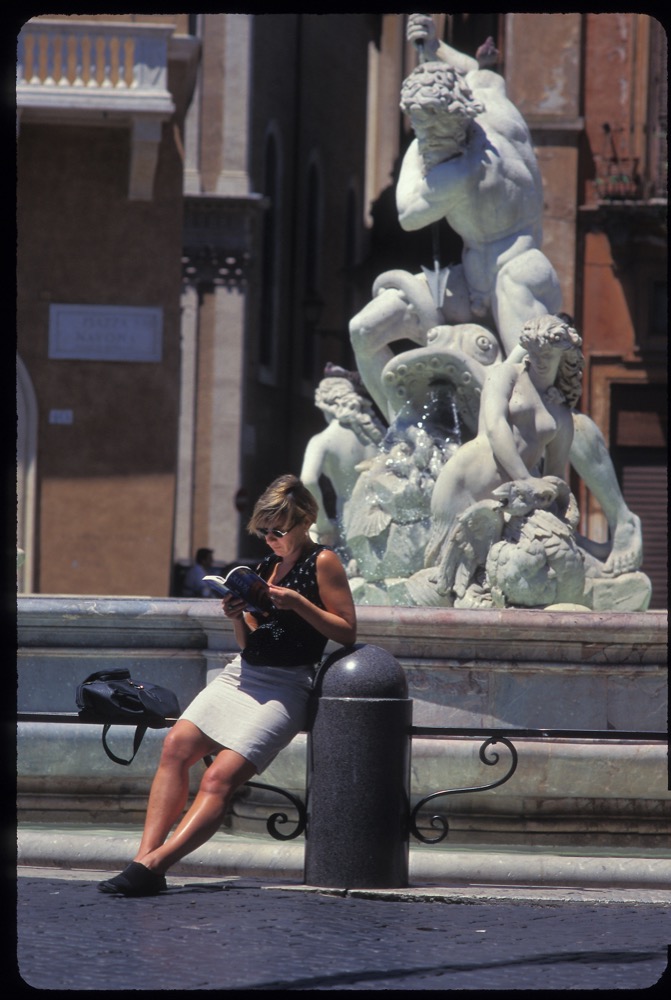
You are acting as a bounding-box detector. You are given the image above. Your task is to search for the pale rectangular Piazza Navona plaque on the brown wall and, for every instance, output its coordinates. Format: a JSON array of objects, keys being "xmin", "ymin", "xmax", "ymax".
[{"xmin": 49, "ymin": 305, "xmax": 163, "ymax": 361}]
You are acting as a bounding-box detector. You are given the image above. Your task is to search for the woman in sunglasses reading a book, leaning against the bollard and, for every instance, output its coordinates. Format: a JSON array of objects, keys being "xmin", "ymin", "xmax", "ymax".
[{"xmin": 98, "ymin": 475, "xmax": 356, "ymax": 896}]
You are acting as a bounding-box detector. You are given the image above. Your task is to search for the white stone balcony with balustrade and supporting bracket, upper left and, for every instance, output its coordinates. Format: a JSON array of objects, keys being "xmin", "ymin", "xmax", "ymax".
[{"xmin": 16, "ymin": 18, "xmax": 180, "ymax": 200}]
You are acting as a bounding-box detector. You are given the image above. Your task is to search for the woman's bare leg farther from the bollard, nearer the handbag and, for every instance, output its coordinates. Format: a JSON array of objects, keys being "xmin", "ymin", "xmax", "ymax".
[{"xmin": 134, "ymin": 719, "xmax": 219, "ymax": 861}]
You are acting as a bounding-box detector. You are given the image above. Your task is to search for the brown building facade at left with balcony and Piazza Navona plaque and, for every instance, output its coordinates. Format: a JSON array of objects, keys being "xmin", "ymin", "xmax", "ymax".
[{"xmin": 17, "ymin": 15, "xmax": 198, "ymax": 594}]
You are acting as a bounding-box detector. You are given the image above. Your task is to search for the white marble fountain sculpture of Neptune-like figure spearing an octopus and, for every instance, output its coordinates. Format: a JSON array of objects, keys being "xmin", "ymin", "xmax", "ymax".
[{"xmin": 302, "ymin": 14, "xmax": 651, "ymax": 611}]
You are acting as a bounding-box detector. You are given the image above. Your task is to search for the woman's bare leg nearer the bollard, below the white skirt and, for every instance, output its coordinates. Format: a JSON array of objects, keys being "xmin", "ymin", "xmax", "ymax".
[{"xmin": 135, "ymin": 749, "xmax": 256, "ymax": 874}]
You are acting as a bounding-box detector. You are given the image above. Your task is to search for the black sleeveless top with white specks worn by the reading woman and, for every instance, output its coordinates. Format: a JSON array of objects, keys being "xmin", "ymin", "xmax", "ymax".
[{"xmin": 242, "ymin": 545, "xmax": 328, "ymax": 667}]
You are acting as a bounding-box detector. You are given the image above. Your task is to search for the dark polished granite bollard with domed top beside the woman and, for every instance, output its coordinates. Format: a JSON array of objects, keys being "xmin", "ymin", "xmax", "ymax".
[{"xmin": 304, "ymin": 644, "xmax": 412, "ymax": 889}]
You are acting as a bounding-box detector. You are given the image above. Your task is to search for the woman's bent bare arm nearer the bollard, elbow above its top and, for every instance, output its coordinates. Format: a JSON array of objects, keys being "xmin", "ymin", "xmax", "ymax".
[{"xmin": 270, "ymin": 549, "xmax": 356, "ymax": 646}]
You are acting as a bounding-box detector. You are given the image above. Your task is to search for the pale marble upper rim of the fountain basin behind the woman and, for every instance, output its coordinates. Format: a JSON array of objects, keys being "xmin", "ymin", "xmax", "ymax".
[{"xmin": 17, "ymin": 594, "xmax": 668, "ymax": 665}]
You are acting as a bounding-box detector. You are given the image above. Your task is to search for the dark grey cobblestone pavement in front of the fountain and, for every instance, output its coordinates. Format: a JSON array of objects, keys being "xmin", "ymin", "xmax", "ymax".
[{"xmin": 14, "ymin": 869, "xmax": 671, "ymax": 997}]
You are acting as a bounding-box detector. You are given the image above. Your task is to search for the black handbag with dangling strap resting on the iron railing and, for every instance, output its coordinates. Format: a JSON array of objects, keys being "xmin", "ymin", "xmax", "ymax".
[{"xmin": 76, "ymin": 669, "xmax": 181, "ymax": 764}]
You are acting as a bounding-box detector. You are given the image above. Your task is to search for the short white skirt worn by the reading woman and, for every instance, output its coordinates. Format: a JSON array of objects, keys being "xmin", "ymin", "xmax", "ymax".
[{"xmin": 181, "ymin": 656, "xmax": 315, "ymax": 774}]
